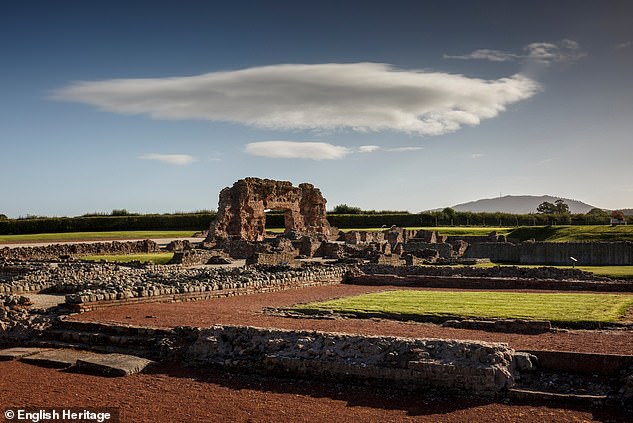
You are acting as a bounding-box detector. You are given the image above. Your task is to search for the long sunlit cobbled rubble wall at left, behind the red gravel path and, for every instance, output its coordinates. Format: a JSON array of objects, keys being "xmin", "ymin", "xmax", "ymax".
[{"xmin": 0, "ymin": 262, "xmax": 348, "ymax": 303}]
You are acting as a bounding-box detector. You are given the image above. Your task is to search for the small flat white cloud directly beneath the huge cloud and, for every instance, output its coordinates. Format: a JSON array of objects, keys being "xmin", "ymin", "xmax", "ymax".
[{"xmin": 245, "ymin": 141, "xmax": 352, "ymax": 160}]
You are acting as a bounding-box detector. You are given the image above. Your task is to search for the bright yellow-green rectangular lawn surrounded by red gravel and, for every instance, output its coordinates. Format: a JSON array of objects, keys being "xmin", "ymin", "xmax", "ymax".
[{"xmin": 292, "ymin": 290, "xmax": 633, "ymax": 327}]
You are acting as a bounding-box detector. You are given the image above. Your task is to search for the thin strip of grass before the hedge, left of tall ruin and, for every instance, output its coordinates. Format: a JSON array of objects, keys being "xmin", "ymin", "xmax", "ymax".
[{"xmin": 0, "ymin": 231, "xmax": 195, "ymax": 243}]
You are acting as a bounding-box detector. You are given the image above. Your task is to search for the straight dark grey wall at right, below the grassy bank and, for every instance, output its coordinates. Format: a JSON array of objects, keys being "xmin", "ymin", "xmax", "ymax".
[{"xmin": 465, "ymin": 241, "xmax": 633, "ymax": 266}]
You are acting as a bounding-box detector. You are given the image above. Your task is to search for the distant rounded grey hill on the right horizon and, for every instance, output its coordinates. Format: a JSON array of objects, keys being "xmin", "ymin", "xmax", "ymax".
[{"xmin": 453, "ymin": 195, "xmax": 595, "ymax": 214}]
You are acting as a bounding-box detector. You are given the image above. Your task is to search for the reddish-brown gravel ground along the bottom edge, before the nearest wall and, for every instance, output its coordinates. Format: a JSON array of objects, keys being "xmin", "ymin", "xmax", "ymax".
[{"xmin": 0, "ymin": 361, "xmax": 630, "ymax": 423}]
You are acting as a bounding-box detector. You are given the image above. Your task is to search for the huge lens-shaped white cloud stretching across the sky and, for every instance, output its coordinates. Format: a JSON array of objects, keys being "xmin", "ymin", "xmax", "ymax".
[{"xmin": 51, "ymin": 63, "xmax": 540, "ymax": 135}]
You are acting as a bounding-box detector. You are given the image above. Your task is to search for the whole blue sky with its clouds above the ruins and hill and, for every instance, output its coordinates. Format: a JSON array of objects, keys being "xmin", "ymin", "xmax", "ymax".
[{"xmin": 0, "ymin": 0, "xmax": 633, "ymax": 217}]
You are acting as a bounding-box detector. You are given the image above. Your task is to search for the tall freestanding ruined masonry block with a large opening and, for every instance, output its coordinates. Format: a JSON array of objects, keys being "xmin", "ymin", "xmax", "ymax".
[{"xmin": 209, "ymin": 178, "xmax": 330, "ymax": 241}]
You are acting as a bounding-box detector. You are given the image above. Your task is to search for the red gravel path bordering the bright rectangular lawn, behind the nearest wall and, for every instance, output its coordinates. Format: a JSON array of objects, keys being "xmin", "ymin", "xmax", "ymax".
[{"xmin": 75, "ymin": 285, "xmax": 633, "ymax": 354}]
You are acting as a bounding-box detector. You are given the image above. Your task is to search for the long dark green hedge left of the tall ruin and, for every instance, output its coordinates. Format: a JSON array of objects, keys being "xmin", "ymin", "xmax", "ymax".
[{"xmin": 0, "ymin": 213, "xmax": 215, "ymax": 235}]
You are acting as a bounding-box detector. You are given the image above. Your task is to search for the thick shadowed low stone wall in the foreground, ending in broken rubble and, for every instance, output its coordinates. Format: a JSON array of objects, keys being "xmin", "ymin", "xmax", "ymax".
[{"xmin": 186, "ymin": 326, "xmax": 517, "ymax": 396}]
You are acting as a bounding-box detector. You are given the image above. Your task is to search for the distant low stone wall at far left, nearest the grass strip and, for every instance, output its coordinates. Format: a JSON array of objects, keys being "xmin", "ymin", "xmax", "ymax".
[{"xmin": 0, "ymin": 239, "xmax": 159, "ymax": 260}]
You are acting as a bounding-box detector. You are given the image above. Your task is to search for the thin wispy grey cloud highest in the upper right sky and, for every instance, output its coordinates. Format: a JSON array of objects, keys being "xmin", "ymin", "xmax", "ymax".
[{"xmin": 444, "ymin": 39, "xmax": 586, "ymax": 66}]
